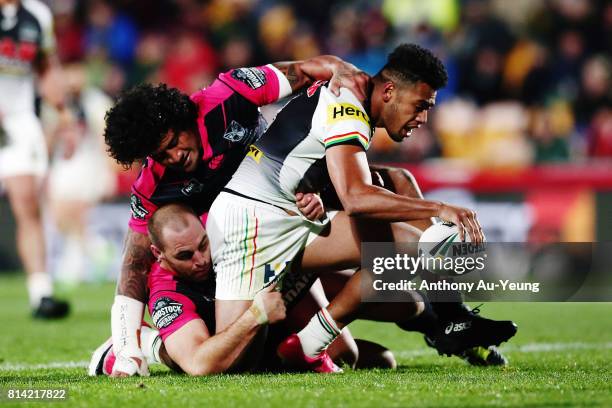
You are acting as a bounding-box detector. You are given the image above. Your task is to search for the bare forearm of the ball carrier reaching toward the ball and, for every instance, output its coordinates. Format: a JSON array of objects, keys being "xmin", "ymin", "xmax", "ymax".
[{"xmin": 338, "ymin": 185, "xmax": 441, "ymax": 222}]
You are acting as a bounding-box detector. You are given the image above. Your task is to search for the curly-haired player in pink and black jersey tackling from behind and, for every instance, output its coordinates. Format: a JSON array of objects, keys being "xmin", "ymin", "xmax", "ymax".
[{"xmin": 105, "ymin": 56, "xmax": 367, "ymax": 376}]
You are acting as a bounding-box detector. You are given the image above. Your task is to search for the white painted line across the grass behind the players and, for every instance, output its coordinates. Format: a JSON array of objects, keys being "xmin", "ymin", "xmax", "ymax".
[{"xmin": 0, "ymin": 342, "xmax": 612, "ymax": 371}]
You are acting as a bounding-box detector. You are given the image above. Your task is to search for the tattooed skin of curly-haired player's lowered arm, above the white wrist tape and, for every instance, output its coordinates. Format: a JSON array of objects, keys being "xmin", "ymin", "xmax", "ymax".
[{"xmin": 117, "ymin": 231, "xmax": 153, "ymax": 303}]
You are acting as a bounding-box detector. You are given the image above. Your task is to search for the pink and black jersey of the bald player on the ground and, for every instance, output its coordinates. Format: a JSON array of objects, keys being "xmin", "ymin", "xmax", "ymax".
[{"xmin": 148, "ymin": 263, "xmax": 215, "ymax": 341}]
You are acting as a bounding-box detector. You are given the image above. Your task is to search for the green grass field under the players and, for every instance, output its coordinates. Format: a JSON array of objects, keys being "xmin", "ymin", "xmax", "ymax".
[{"xmin": 0, "ymin": 275, "xmax": 612, "ymax": 407}]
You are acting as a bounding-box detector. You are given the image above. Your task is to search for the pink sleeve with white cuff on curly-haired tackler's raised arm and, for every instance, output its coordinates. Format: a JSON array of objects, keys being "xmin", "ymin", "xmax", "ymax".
[{"xmin": 219, "ymin": 65, "xmax": 291, "ymax": 106}]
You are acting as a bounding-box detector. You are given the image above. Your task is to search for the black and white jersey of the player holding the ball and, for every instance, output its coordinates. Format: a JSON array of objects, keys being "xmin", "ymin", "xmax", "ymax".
[{"xmin": 226, "ymin": 82, "xmax": 373, "ymax": 215}]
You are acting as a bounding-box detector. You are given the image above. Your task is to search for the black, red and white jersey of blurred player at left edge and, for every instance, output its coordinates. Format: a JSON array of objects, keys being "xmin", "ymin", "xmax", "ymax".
[{"xmin": 0, "ymin": 0, "xmax": 55, "ymax": 115}]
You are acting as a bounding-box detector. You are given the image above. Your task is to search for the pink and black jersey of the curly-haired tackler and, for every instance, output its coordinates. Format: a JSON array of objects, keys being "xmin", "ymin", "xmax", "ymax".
[{"xmin": 129, "ymin": 65, "xmax": 291, "ymax": 234}]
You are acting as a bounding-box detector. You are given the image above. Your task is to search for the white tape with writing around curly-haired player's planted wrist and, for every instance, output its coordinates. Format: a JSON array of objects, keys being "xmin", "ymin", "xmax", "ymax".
[{"xmin": 111, "ymin": 295, "xmax": 144, "ymax": 355}]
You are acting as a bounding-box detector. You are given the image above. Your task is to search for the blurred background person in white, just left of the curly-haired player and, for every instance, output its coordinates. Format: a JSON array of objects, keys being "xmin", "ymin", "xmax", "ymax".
[{"xmin": 41, "ymin": 63, "xmax": 117, "ymax": 284}]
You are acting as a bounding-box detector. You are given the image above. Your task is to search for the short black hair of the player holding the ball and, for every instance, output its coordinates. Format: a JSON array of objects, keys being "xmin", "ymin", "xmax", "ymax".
[{"xmin": 376, "ymin": 44, "xmax": 448, "ymax": 90}]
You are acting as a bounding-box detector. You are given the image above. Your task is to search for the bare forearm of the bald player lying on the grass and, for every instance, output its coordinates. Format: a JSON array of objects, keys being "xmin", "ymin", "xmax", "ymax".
[{"xmin": 189, "ymin": 309, "xmax": 262, "ymax": 375}]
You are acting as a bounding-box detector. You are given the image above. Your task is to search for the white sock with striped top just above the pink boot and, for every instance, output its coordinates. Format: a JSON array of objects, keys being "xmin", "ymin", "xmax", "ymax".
[{"xmin": 297, "ymin": 308, "xmax": 341, "ymax": 358}]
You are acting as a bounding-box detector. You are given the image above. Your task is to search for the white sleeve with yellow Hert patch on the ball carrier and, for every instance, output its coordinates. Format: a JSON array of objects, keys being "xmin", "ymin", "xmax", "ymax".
[{"xmin": 318, "ymin": 88, "xmax": 372, "ymax": 151}]
